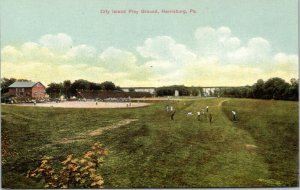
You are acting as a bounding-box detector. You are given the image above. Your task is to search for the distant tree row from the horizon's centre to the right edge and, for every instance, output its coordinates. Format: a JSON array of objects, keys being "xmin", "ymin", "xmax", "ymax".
[{"xmin": 156, "ymin": 77, "xmax": 299, "ymax": 101}]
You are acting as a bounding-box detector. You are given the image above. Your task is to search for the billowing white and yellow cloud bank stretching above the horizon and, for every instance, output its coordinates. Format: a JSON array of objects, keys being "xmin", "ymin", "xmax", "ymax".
[{"xmin": 1, "ymin": 27, "xmax": 298, "ymax": 86}]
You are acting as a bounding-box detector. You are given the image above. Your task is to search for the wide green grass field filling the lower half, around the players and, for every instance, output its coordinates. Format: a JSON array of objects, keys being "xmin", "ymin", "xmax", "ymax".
[{"xmin": 1, "ymin": 98, "xmax": 299, "ymax": 188}]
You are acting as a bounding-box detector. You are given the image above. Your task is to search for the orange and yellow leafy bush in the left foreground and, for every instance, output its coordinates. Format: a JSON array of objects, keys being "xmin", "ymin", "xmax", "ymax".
[{"xmin": 27, "ymin": 143, "xmax": 108, "ymax": 188}]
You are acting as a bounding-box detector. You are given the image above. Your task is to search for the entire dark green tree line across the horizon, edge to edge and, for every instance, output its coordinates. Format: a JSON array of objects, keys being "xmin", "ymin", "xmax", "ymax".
[{"xmin": 1, "ymin": 77, "xmax": 299, "ymax": 101}]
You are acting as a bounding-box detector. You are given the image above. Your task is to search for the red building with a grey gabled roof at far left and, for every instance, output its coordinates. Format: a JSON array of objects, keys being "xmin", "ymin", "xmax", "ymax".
[{"xmin": 8, "ymin": 81, "xmax": 46, "ymax": 98}]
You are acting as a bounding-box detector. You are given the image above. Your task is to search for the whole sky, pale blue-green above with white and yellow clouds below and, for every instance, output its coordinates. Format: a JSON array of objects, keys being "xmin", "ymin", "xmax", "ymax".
[{"xmin": 1, "ymin": 0, "xmax": 298, "ymax": 86}]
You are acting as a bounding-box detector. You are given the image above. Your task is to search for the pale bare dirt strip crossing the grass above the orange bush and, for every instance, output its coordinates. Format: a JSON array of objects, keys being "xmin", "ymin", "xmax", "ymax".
[{"xmin": 52, "ymin": 119, "xmax": 137, "ymax": 145}]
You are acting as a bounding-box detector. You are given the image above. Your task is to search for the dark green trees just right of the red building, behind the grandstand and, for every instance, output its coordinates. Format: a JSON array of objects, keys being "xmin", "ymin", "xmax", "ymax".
[{"xmin": 46, "ymin": 79, "xmax": 122, "ymax": 98}]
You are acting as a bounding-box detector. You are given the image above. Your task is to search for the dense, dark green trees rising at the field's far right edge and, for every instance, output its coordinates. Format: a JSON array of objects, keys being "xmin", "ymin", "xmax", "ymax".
[{"xmin": 214, "ymin": 77, "xmax": 299, "ymax": 100}]
